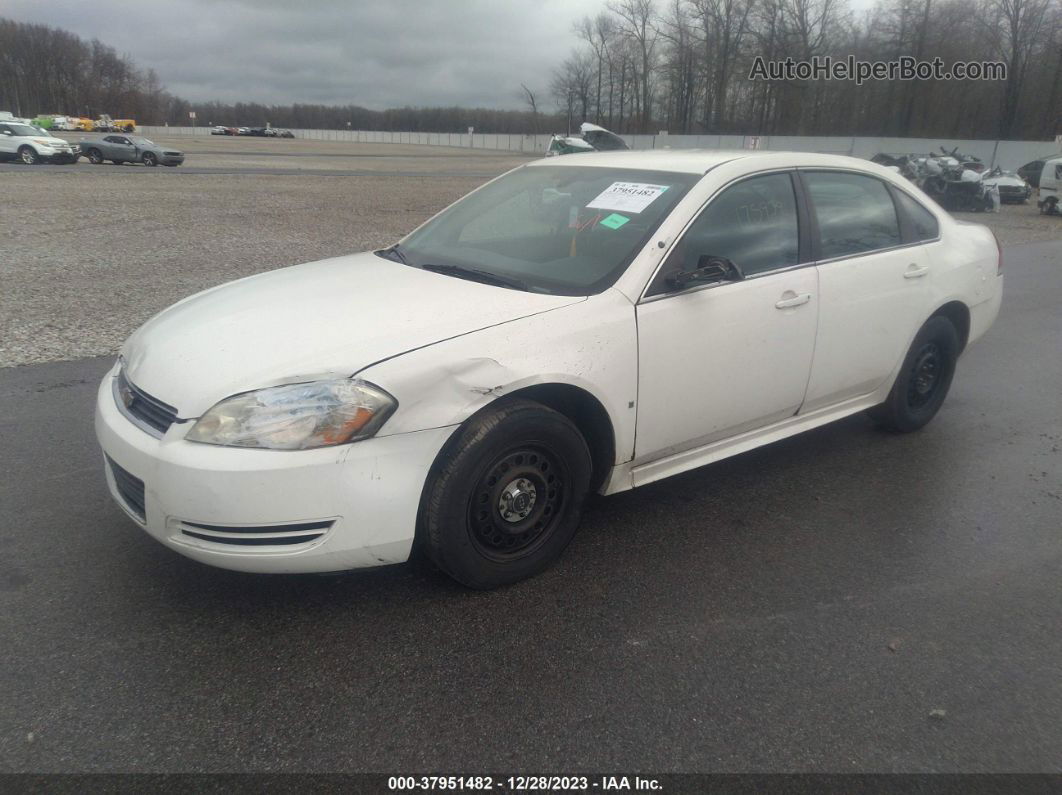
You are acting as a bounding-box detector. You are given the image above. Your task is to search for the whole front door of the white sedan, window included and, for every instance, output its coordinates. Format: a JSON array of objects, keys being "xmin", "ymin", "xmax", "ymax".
[{"xmin": 634, "ymin": 172, "xmax": 819, "ymax": 465}]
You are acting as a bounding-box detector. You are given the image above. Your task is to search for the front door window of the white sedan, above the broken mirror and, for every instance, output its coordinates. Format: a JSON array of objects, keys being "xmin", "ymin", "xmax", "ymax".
[{"xmin": 651, "ymin": 169, "xmax": 800, "ymax": 284}]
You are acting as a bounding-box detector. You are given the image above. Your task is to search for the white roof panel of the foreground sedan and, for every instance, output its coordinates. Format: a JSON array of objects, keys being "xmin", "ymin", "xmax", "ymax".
[{"xmin": 528, "ymin": 149, "xmax": 892, "ymax": 174}]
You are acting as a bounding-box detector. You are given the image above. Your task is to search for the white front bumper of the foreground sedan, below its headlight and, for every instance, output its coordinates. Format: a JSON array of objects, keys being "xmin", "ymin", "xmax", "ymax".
[{"xmin": 96, "ymin": 367, "xmax": 453, "ymax": 572}]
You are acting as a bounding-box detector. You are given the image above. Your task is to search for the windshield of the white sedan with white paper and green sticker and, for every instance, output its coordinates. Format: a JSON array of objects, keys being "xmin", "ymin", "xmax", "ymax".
[{"xmin": 400, "ymin": 166, "xmax": 700, "ymax": 295}]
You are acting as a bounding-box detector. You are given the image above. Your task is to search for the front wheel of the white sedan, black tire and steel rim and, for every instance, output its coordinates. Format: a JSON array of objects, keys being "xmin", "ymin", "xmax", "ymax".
[{"xmin": 422, "ymin": 400, "xmax": 592, "ymax": 590}]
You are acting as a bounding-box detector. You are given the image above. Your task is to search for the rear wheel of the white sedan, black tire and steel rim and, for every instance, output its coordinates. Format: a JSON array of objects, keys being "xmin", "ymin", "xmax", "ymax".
[{"xmin": 869, "ymin": 315, "xmax": 960, "ymax": 433}]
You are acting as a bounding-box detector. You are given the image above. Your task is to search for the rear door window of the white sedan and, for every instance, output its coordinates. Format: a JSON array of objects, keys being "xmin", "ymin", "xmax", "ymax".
[{"xmin": 804, "ymin": 171, "xmax": 902, "ymax": 259}]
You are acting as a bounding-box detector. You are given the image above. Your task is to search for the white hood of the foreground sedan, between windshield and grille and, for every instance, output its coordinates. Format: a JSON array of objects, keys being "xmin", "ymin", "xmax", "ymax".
[{"xmin": 122, "ymin": 253, "xmax": 585, "ymax": 418}]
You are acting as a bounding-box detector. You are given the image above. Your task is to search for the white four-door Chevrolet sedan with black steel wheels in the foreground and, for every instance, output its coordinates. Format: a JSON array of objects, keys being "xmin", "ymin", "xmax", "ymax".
[{"xmin": 96, "ymin": 152, "xmax": 1003, "ymax": 588}]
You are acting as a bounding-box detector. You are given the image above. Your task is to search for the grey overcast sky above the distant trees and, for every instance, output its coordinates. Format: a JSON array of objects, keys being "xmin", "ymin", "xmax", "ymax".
[{"xmin": 0, "ymin": 0, "xmax": 604, "ymax": 109}]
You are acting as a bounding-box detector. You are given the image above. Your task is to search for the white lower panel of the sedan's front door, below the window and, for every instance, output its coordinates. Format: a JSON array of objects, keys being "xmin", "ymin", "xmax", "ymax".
[{"xmin": 635, "ymin": 267, "xmax": 819, "ymax": 464}]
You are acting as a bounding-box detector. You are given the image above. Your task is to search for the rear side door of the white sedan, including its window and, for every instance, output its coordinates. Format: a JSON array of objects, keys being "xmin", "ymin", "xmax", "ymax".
[{"xmin": 800, "ymin": 170, "xmax": 938, "ymax": 413}]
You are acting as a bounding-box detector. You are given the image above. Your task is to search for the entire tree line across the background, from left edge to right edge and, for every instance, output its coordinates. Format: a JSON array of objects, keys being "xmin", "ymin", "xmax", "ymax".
[{"xmin": 0, "ymin": 0, "xmax": 1062, "ymax": 139}]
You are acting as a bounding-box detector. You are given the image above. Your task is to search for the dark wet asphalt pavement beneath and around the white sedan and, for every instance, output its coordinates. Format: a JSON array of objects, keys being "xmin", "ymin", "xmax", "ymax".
[{"xmin": 0, "ymin": 243, "xmax": 1062, "ymax": 774}]
